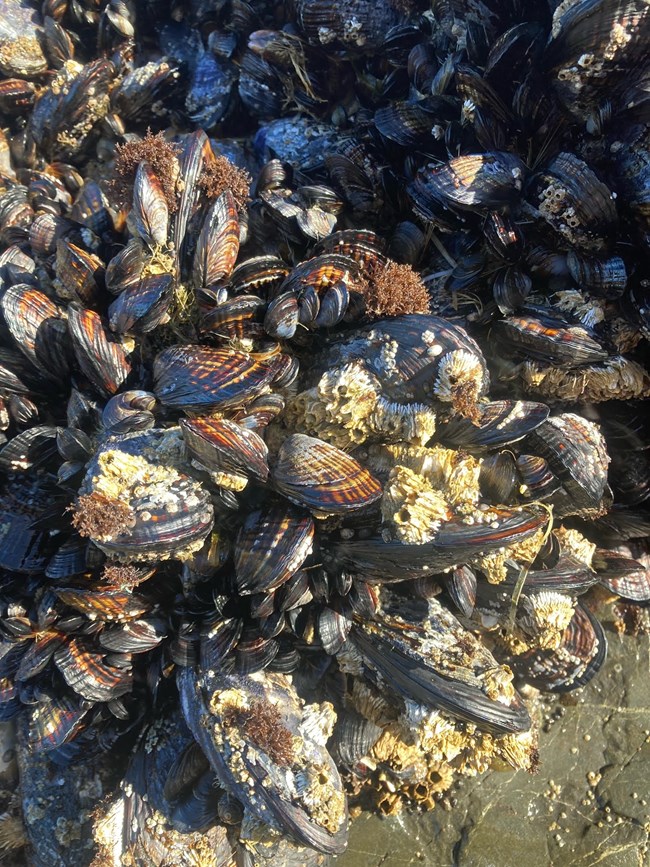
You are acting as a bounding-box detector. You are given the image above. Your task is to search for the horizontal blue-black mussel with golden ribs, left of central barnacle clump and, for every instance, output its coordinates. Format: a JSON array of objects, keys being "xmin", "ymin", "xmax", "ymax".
[{"xmin": 154, "ymin": 345, "xmax": 275, "ymax": 410}]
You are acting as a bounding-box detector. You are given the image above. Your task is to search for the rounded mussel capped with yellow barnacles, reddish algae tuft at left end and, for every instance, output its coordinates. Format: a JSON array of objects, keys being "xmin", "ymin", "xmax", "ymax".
[{"xmin": 73, "ymin": 428, "xmax": 213, "ymax": 561}]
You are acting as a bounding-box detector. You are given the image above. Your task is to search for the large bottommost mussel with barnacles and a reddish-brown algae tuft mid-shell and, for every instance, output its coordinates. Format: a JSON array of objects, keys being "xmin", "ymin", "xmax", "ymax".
[{"xmin": 178, "ymin": 668, "xmax": 347, "ymax": 854}]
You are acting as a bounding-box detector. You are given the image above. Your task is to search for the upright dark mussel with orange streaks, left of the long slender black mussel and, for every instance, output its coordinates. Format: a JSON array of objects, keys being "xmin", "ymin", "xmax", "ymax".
[{"xmin": 234, "ymin": 506, "xmax": 314, "ymax": 594}]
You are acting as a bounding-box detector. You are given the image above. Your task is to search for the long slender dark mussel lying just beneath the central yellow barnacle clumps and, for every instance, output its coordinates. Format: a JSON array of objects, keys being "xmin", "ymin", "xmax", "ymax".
[{"xmin": 330, "ymin": 509, "xmax": 548, "ymax": 584}]
